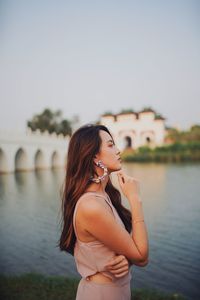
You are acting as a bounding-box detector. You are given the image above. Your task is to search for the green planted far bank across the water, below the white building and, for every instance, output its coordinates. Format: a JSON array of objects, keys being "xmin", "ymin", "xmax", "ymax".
[{"xmin": 121, "ymin": 141, "xmax": 200, "ymax": 162}]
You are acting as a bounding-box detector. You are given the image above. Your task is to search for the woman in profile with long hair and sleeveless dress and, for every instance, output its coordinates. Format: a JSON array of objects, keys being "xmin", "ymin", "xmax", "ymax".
[{"xmin": 59, "ymin": 124, "xmax": 148, "ymax": 300}]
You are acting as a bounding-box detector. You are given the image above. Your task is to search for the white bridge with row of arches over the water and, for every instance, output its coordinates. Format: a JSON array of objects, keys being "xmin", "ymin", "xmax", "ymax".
[{"xmin": 0, "ymin": 129, "xmax": 70, "ymax": 173}]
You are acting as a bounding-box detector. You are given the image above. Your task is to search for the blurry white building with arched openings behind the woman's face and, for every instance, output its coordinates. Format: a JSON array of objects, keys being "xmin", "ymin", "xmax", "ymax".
[{"xmin": 100, "ymin": 109, "xmax": 166, "ymax": 151}]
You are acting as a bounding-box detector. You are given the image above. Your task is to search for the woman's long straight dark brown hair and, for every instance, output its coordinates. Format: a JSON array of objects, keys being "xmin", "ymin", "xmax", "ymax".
[{"xmin": 58, "ymin": 124, "xmax": 132, "ymax": 255}]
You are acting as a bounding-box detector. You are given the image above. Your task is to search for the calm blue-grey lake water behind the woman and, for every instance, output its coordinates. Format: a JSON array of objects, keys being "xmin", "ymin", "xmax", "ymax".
[{"xmin": 0, "ymin": 163, "xmax": 200, "ymax": 300}]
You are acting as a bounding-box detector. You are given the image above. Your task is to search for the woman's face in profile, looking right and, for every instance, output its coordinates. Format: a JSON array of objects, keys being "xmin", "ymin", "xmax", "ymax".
[{"xmin": 95, "ymin": 130, "xmax": 122, "ymax": 173}]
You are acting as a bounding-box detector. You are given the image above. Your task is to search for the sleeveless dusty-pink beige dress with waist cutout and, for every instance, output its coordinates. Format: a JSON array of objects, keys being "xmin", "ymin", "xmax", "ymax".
[{"xmin": 73, "ymin": 192, "xmax": 131, "ymax": 300}]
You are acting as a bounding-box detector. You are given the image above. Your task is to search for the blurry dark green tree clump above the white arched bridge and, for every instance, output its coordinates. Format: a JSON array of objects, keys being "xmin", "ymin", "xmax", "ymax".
[{"xmin": 27, "ymin": 108, "xmax": 72, "ymax": 135}]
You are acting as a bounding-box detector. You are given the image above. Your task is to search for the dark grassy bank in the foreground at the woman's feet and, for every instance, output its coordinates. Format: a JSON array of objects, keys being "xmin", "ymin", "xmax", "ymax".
[{"xmin": 0, "ymin": 273, "xmax": 186, "ymax": 300}]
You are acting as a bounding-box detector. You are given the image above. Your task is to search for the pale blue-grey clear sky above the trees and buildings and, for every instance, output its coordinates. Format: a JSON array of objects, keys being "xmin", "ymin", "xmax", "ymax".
[{"xmin": 0, "ymin": 0, "xmax": 200, "ymax": 130}]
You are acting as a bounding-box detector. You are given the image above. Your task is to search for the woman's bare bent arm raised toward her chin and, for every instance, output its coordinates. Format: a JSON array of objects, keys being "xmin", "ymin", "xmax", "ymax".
[{"xmin": 80, "ymin": 194, "xmax": 148, "ymax": 264}]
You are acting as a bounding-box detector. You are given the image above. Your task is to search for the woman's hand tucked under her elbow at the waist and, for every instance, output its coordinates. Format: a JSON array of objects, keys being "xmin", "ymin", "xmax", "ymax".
[{"xmin": 106, "ymin": 255, "xmax": 129, "ymax": 278}]
